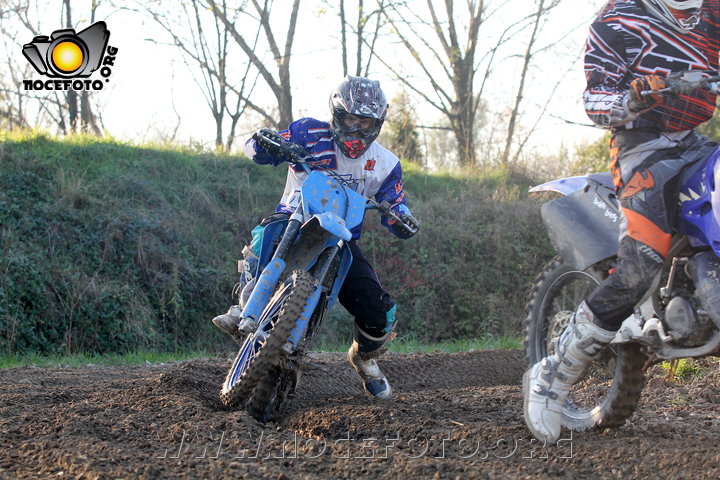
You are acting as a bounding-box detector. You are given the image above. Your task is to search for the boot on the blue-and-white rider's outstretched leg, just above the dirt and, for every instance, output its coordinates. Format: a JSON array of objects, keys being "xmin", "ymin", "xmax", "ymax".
[{"xmin": 348, "ymin": 326, "xmax": 392, "ymax": 400}]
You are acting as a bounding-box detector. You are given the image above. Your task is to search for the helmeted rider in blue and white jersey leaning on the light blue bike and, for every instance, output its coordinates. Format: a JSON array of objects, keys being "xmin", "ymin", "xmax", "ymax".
[{"xmin": 212, "ymin": 75, "xmax": 419, "ymax": 399}]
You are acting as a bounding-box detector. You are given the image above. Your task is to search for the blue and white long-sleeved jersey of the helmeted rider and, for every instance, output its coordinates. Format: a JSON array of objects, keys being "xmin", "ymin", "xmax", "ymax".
[{"xmin": 245, "ymin": 118, "xmax": 410, "ymax": 239}]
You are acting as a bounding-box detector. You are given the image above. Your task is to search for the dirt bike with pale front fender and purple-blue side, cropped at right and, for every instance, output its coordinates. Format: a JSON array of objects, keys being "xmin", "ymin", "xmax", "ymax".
[{"xmin": 524, "ymin": 71, "xmax": 720, "ymax": 431}]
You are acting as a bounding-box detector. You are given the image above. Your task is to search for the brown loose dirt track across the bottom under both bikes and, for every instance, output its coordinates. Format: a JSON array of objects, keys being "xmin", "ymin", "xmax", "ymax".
[{"xmin": 0, "ymin": 350, "xmax": 720, "ymax": 480}]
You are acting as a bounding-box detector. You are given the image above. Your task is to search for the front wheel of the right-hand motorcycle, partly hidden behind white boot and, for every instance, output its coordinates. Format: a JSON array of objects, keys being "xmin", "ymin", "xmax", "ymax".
[{"xmin": 524, "ymin": 256, "xmax": 646, "ymax": 431}]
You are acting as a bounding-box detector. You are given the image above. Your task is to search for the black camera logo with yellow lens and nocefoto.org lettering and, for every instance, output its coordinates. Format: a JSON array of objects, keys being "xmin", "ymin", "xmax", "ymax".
[{"xmin": 22, "ymin": 22, "xmax": 117, "ymax": 90}]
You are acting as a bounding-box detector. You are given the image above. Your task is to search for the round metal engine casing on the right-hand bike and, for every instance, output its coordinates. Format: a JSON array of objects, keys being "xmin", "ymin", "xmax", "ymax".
[{"xmin": 664, "ymin": 296, "xmax": 715, "ymax": 347}]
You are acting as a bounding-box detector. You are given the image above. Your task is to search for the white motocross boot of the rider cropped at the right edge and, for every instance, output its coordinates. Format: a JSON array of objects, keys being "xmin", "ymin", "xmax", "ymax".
[{"xmin": 523, "ymin": 302, "xmax": 615, "ymax": 445}]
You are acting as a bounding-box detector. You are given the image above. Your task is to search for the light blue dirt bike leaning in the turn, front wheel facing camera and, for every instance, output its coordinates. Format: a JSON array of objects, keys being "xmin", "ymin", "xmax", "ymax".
[{"xmin": 220, "ymin": 132, "xmax": 414, "ymax": 423}]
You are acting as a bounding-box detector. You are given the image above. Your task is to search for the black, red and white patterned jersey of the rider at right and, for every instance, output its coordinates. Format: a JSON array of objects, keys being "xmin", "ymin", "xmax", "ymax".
[{"xmin": 583, "ymin": 0, "xmax": 720, "ymax": 131}]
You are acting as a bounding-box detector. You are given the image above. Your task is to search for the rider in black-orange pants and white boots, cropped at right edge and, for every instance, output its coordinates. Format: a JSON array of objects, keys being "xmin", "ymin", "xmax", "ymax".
[{"xmin": 523, "ymin": 0, "xmax": 720, "ymax": 444}]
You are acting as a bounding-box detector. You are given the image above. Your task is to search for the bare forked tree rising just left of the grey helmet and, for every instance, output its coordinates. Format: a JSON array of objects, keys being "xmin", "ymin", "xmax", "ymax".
[{"xmin": 208, "ymin": 0, "xmax": 300, "ymax": 129}]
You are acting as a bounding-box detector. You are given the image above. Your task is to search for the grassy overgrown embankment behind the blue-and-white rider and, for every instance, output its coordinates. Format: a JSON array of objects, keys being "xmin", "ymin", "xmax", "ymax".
[{"xmin": 0, "ymin": 133, "xmax": 552, "ymax": 354}]
